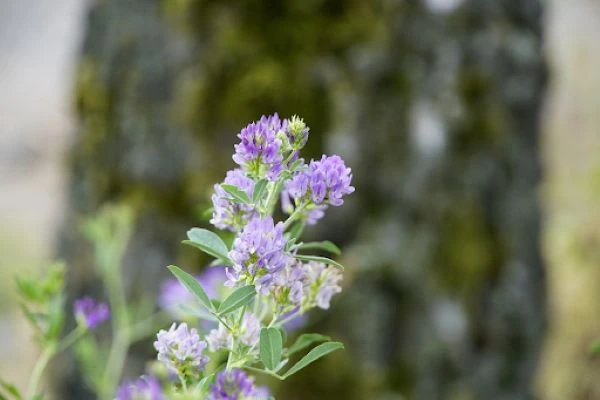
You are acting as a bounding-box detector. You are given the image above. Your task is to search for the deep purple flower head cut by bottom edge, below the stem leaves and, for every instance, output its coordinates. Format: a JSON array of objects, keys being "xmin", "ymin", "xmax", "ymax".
[{"xmin": 208, "ymin": 369, "xmax": 269, "ymax": 400}]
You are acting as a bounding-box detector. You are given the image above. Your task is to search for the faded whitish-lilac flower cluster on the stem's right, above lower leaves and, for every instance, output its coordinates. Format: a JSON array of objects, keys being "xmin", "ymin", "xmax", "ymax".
[{"xmin": 272, "ymin": 261, "xmax": 342, "ymax": 312}]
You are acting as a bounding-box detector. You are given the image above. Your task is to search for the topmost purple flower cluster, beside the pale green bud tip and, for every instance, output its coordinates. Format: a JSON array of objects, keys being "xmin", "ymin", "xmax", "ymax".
[{"xmin": 233, "ymin": 113, "xmax": 287, "ymax": 181}]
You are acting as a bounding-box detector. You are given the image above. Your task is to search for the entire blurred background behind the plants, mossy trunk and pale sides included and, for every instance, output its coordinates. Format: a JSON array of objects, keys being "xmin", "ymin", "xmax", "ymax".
[{"xmin": 0, "ymin": 0, "xmax": 600, "ymax": 400}]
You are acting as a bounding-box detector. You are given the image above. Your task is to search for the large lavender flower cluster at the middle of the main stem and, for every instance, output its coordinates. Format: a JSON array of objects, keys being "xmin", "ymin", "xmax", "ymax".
[{"xmin": 226, "ymin": 217, "xmax": 290, "ymax": 293}]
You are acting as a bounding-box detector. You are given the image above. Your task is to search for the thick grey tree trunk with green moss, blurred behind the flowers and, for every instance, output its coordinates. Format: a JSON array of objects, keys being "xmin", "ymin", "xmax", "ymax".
[{"xmin": 60, "ymin": 0, "xmax": 545, "ymax": 399}]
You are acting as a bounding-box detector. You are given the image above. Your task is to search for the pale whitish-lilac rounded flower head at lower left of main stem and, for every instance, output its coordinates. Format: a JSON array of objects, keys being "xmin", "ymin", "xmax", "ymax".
[{"xmin": 154, "ymin": 323, "xmax": 208, "ymax": 376}]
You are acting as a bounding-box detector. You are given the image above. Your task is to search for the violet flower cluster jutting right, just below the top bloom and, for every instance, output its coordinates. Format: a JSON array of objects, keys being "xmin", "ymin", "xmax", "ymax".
[{"xmin": 285, "ymin": 155, "xmax": 354, "ymax": 206}]
